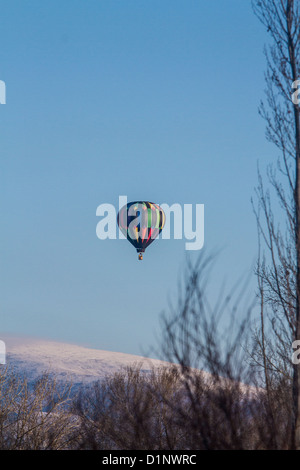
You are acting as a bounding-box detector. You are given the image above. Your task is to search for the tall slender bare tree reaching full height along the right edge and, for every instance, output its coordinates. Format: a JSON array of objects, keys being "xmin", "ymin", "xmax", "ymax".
[{"xmin": 252, "ymin": 0, "xmax": 300, "ymax": 449}]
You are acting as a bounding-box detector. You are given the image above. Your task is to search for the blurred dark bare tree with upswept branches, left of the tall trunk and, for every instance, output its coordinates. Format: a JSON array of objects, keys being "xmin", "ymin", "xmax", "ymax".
[{"xmin": 157, "ymin": 254, "xmax": 291, "ymax": 450}]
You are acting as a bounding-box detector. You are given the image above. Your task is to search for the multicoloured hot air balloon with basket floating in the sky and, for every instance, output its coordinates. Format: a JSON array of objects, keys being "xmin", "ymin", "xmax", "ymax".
[{"xmin": 117, "ymin": 201, "xmax": 166, "ymax": 260}]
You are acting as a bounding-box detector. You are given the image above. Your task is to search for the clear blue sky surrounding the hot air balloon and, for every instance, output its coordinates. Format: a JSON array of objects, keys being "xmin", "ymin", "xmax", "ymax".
[{"xmin": 0, "ymin": 0, "xmax": 276, "ymax": 354}]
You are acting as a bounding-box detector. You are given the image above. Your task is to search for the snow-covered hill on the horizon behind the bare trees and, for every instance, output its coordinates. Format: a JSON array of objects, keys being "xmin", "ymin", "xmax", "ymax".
[{"xmin": 0, "ymin": 336, "xmax": 171, "ymax": 385}]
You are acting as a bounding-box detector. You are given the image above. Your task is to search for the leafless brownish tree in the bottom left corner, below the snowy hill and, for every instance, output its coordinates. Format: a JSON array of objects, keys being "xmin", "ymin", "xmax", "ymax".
[{"xmin": 0, "ymin": 369, "xmax": 78, "ymax": 450}]
